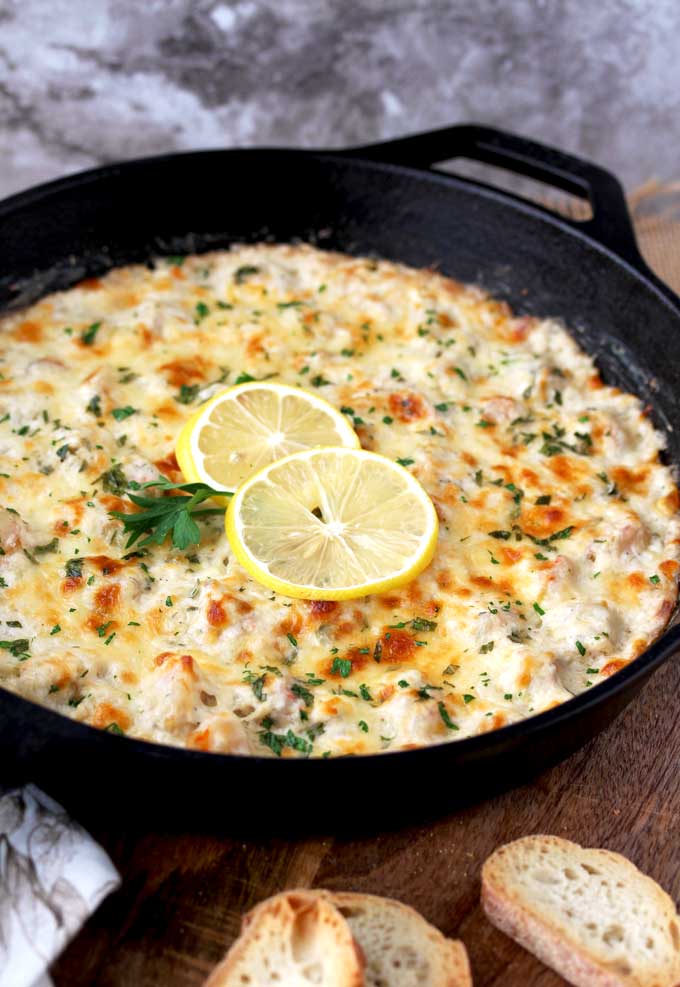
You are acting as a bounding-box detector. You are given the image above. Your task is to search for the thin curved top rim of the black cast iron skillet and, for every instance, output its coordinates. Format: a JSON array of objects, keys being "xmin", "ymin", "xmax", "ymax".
[{"xmin": 0, "ymin": 145, "xmax": 680, "ymax": 774}]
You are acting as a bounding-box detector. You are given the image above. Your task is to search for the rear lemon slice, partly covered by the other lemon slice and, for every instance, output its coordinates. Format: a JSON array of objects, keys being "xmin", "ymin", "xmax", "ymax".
[{"xmin": 175, "ymin": 381, "xmax": 359, "ymax": 492}]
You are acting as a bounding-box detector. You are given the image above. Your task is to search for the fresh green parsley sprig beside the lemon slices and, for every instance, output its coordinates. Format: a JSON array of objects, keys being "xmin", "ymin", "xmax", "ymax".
[{"xmin": 109, "ymin": 480, "xmax": 231, "ymax": 550}]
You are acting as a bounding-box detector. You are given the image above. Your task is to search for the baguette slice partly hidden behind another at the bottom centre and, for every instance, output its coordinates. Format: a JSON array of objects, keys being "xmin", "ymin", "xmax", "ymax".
[{"xmin": 326, "ymin": 892, "xmax": 472, "ymax": 987}]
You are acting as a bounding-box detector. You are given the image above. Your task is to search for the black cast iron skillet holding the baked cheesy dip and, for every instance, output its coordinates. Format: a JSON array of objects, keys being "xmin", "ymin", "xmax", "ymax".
[{"xmin": 0, "ymin": 126, "xmax": 680, "ymax": 829}]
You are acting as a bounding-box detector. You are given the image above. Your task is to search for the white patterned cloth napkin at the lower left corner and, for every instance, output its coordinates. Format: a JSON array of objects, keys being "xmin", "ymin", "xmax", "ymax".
[{"xmin": 0, "ymin": 785, "xmax": 120, "ymax": 987}]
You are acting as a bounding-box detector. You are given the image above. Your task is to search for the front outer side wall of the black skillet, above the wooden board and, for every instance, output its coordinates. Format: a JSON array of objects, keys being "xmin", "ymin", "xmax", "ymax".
[{"xmin": 0, "ymin": 668, "xmax": 652, "ymax": 836}]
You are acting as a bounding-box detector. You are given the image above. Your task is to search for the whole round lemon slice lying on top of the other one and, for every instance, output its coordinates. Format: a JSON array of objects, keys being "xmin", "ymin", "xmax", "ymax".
[{"xmin": 226, "ymin": 449, "xmax": 438, "ymax": 600}]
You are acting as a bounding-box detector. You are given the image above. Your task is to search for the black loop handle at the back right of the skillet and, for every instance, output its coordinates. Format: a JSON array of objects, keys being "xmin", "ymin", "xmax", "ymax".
[{"xmin": 347, "ymin": 124, "xmax": 648, "ymax": 274}]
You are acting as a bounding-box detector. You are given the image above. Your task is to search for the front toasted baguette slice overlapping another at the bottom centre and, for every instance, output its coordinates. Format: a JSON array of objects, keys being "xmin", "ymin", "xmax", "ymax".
[{"xmin": 204, "ymin": 891, "xmax": 364, "ymax": 987}]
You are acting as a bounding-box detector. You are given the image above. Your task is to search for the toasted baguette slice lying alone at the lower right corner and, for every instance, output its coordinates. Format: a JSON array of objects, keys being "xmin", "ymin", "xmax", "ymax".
[{"xmin": 482, "ymin": 836, "xmax": 680, "ymax": 987}]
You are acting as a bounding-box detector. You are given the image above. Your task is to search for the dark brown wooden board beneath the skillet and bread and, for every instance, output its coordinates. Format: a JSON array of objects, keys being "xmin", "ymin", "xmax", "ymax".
[{"xmin": 52, "ymin": 659, "xmax": 680, "ymax": 987}]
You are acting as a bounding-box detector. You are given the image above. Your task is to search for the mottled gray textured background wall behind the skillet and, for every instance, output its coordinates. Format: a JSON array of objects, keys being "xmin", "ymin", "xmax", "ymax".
[{"xmin": 0, "ymin": 0, "xmax": 680, "ymax": 202}]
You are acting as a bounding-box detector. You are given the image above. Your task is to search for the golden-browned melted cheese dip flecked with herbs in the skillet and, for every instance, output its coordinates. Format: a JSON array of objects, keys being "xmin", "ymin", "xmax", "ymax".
[{"xmin": 0, "ymin": 246, "xmax": 680, "ymax": 757}]
